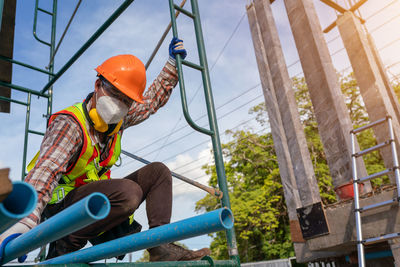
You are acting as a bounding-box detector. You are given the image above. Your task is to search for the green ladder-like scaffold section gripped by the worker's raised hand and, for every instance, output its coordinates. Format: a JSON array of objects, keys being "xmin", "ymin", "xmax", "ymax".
[{"xmin": 169, "ymin": 0, "xmax": 240, "ymax": 265}]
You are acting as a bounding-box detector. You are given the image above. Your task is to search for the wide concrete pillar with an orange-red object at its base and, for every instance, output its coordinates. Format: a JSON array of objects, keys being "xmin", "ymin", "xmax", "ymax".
[{"xmin": 284, "ymin": 0, "xmax": 371, "ymax": 194}]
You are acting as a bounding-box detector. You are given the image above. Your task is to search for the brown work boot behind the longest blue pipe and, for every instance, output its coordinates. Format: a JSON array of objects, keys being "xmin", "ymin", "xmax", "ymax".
[{"xmin": 147, "ymin": 243, "xmax": 211, "ymax": 261}]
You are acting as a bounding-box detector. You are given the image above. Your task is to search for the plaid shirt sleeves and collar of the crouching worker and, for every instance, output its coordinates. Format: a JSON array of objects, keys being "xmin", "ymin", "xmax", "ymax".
[{"xmin": 20, "ymin": 61, "xmax": 178, "ymax": 228}]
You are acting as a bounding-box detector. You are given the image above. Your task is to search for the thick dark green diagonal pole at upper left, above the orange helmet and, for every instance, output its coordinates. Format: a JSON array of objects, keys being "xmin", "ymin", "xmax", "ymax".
[{"xmin": 41, "ymin": 0, "xmax": 134, "ymax": 93}]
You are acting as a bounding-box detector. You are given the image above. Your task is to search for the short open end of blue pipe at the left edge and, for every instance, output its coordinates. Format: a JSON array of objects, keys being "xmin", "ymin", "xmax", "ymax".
[{"xmin": 0, "ymin": 181, "xmax": 37, "ymax": 234}]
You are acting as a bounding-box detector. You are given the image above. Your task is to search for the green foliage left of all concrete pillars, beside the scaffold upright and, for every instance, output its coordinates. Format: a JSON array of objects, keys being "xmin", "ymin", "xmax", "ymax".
[{"xmin": 196, "ymin": 131, "xmax": 294, "ymax": 261}]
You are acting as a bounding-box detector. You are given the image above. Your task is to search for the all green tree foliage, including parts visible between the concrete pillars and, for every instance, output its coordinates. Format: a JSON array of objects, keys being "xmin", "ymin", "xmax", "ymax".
[{"xmin": 196, "ymin": 74, "xmax": 400, "ymax": 262}]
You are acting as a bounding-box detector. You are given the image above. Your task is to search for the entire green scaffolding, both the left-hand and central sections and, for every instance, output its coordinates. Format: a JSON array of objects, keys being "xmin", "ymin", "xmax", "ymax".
[{"xmin": 0, "ymin": 0, "xmax": 240, "ymax": 267}]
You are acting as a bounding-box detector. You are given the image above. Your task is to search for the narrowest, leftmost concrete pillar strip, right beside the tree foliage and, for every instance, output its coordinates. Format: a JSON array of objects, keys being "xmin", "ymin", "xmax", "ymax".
[{"xmin": 247, "ymin": 4, "xmax": 301, "ymax": 222}]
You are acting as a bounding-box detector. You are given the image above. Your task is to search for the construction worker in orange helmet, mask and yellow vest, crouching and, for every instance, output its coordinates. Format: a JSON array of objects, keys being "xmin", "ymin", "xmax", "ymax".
[{"xmin": 0, "ymin": 38, "xmax": 210, "ymax": 261}]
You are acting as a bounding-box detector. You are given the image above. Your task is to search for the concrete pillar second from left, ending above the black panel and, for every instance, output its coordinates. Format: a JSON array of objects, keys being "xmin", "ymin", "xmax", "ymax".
[{"xmin": 254, "ymin": 0, "xmax": 321, "ymax": 207}]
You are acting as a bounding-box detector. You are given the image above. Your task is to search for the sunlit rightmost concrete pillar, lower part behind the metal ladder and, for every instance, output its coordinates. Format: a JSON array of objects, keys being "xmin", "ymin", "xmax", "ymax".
[{"xmin": 337, "ymin": 12, "xmax": 400, "ymax": 182}]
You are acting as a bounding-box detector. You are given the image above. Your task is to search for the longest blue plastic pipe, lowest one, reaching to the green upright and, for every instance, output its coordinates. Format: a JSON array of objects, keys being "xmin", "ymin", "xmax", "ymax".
[{"xmin": 40, "ymin": 208, "xmax": 233, "ymax": 264}]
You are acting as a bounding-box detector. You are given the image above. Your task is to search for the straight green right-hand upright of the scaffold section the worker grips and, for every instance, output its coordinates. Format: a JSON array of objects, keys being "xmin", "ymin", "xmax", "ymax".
[{"xmin": 191, "ymin": 0, "xmax": 240, "ymax": 265}]
